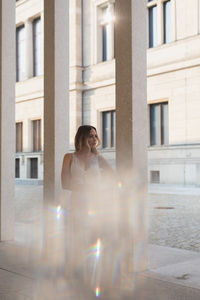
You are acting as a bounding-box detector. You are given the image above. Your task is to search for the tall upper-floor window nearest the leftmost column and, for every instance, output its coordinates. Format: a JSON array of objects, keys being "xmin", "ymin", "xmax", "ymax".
[{"xmin": 16, "ymin": 25, "xmax": 26, "ymax": 81}]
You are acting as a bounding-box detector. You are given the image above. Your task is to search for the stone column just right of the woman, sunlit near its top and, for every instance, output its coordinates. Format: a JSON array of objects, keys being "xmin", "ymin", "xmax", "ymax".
[{"xmin": 115, "ymin": 0, "xmax": 147, "ymax": 273}]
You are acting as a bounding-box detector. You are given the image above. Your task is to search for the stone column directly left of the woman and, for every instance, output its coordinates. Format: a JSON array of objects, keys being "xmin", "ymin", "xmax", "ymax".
[{"xmin": 44, "ymin": 0, "xmax": 69, "ymax": 204}]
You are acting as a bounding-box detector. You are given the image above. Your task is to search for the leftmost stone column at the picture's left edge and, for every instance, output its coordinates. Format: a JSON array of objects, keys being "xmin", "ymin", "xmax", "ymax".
[{"xmin": 0, "ymin": 0, "xmax": 16, "ymax": 241}]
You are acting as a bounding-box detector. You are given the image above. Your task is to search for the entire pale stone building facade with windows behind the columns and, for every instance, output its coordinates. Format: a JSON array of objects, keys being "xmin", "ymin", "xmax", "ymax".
[{"xmin": 16, "ymin": 0, "xmax": 200, "ymax": 185}]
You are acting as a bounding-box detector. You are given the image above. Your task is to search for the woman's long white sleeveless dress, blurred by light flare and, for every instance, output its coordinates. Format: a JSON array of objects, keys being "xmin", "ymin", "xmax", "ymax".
[{"xmin": 68, "ymin": 154, "xmax": 117, "ymax": 291}]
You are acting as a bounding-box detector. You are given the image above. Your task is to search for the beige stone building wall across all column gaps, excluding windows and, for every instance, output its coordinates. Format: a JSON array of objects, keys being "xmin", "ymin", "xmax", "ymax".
[{"xmin": 16, "ymin": 0, "xmax": 200, "ymax": 184}]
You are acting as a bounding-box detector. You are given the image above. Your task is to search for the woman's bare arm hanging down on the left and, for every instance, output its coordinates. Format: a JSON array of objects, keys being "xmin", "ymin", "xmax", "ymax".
[{"xmin": 61, "ymin": 153, "xmax": 72, "ymax": 190}]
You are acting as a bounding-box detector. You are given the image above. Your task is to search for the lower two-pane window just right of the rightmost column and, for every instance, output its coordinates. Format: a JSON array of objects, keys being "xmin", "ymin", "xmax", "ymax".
[{"xmin": 150, "ymin": 102, "xmax": 169, "ymax": 146}]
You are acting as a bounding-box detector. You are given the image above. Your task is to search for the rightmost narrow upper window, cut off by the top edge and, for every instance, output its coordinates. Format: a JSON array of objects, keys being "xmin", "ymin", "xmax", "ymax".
[{"xmin": 163, "ymin": 1, "xmax": 171, "ymax": 44}]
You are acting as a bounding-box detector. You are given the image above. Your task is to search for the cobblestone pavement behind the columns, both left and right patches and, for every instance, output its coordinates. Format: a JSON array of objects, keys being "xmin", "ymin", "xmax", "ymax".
[{"xmin": 15, "ymin": 185, "xmax": 200, "ymax": 252}]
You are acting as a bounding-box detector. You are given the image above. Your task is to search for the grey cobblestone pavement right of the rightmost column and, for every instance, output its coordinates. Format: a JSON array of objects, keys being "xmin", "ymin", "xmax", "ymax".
[{"xmin": 148, "ymin": 194, "xmax": 200, "ymax": 252}]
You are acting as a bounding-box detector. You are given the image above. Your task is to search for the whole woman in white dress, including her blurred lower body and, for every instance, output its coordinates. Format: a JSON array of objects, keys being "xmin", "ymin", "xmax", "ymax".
[{"xmin": 61, "ymin": 125, "xmax": 118, "ymax": 298}]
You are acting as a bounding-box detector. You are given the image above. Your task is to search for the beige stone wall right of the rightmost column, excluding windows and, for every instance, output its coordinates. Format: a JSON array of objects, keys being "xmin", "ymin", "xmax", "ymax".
[{"xmin": 147, "ymin": 0, "xmax": 200, "ymax": 185}]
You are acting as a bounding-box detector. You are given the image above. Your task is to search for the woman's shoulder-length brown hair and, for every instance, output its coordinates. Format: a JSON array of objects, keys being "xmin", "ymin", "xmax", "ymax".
[{"xmin": 74, "ymin": 125, "xmax": 101, "ymax": 152}]
